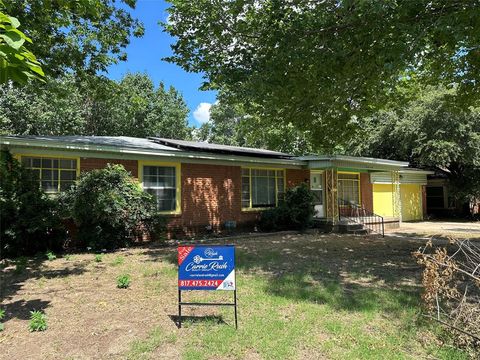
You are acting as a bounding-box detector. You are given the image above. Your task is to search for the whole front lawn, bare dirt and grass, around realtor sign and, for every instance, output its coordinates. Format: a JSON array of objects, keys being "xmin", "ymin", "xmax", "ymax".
[{"xmin": 0, "ymin": 234, "xmax": 467, "ymax": 359}]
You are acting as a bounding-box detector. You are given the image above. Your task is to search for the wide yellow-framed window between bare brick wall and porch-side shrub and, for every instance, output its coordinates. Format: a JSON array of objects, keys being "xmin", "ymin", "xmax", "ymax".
[{"xmin": 242, "ymin": 169, "xmax": 285, "ymax": 208}]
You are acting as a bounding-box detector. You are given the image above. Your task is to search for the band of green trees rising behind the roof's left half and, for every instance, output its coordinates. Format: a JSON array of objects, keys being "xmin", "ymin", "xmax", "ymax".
[{"xmin": 0, "ymin": 74, "xmax": 191, "ymax": 139}]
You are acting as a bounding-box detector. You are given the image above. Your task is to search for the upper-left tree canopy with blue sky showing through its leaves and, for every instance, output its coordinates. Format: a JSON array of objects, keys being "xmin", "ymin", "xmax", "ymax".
[{"xmin": 4, "ymin": 0, "xmax": 144, "ymax": 78}]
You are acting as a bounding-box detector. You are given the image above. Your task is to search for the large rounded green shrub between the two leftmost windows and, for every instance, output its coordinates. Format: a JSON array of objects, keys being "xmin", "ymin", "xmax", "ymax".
[{"xmin": 62, "ymin": 164, "xmax": 165, "ymax": 250}]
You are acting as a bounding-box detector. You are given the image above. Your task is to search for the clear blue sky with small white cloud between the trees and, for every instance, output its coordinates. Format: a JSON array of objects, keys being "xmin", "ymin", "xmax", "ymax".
[{"xmin": 107, "ymin": 0, "xmax": 216, "ymax": 127}]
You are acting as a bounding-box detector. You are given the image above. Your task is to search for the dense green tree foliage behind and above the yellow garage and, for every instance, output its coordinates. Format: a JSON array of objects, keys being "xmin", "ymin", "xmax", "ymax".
[{"xmin": 351, "ymin": 87, "xmax": 480, "ymax": 205}]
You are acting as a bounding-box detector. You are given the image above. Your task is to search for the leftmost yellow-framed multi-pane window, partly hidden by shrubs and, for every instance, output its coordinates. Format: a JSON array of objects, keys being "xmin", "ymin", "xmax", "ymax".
[{"xmin": 22, "ymin": 156, "xmax": 77, "ymax": 193}]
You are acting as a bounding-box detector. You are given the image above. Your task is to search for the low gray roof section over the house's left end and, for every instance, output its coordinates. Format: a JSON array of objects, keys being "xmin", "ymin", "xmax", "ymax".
[{"xmin": 4, "ymin": 135, "xmax": 180, "ymax": 151}]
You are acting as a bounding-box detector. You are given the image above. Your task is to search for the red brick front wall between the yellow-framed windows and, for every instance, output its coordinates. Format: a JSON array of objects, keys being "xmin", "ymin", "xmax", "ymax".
[{"xmin": 76, "ymin": 158, "xmax": 310, "ymax": 235}]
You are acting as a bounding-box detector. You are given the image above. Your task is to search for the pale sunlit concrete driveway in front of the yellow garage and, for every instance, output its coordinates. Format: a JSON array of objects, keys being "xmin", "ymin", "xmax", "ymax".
[{"xmin": 388, "ymin": 221, "xmax": 480, "ymax": 239}]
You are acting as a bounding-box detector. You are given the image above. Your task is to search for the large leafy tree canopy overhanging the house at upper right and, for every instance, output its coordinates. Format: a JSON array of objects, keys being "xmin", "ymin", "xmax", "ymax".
[{"xmin": 164, "ymin": 0, "xmax": 480, "ymax": 147}]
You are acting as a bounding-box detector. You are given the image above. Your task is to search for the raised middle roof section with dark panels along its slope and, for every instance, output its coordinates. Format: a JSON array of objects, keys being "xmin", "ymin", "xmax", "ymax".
[{"xmin": 150, "ymin": 137, "xmax": 293, "ymax": 158}]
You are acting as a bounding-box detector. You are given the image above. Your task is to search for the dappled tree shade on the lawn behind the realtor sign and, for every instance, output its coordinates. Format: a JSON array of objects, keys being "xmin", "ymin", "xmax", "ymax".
[{"xmin": 145, "ymin": 234, "xmax": 423, "ymax": 313}]
